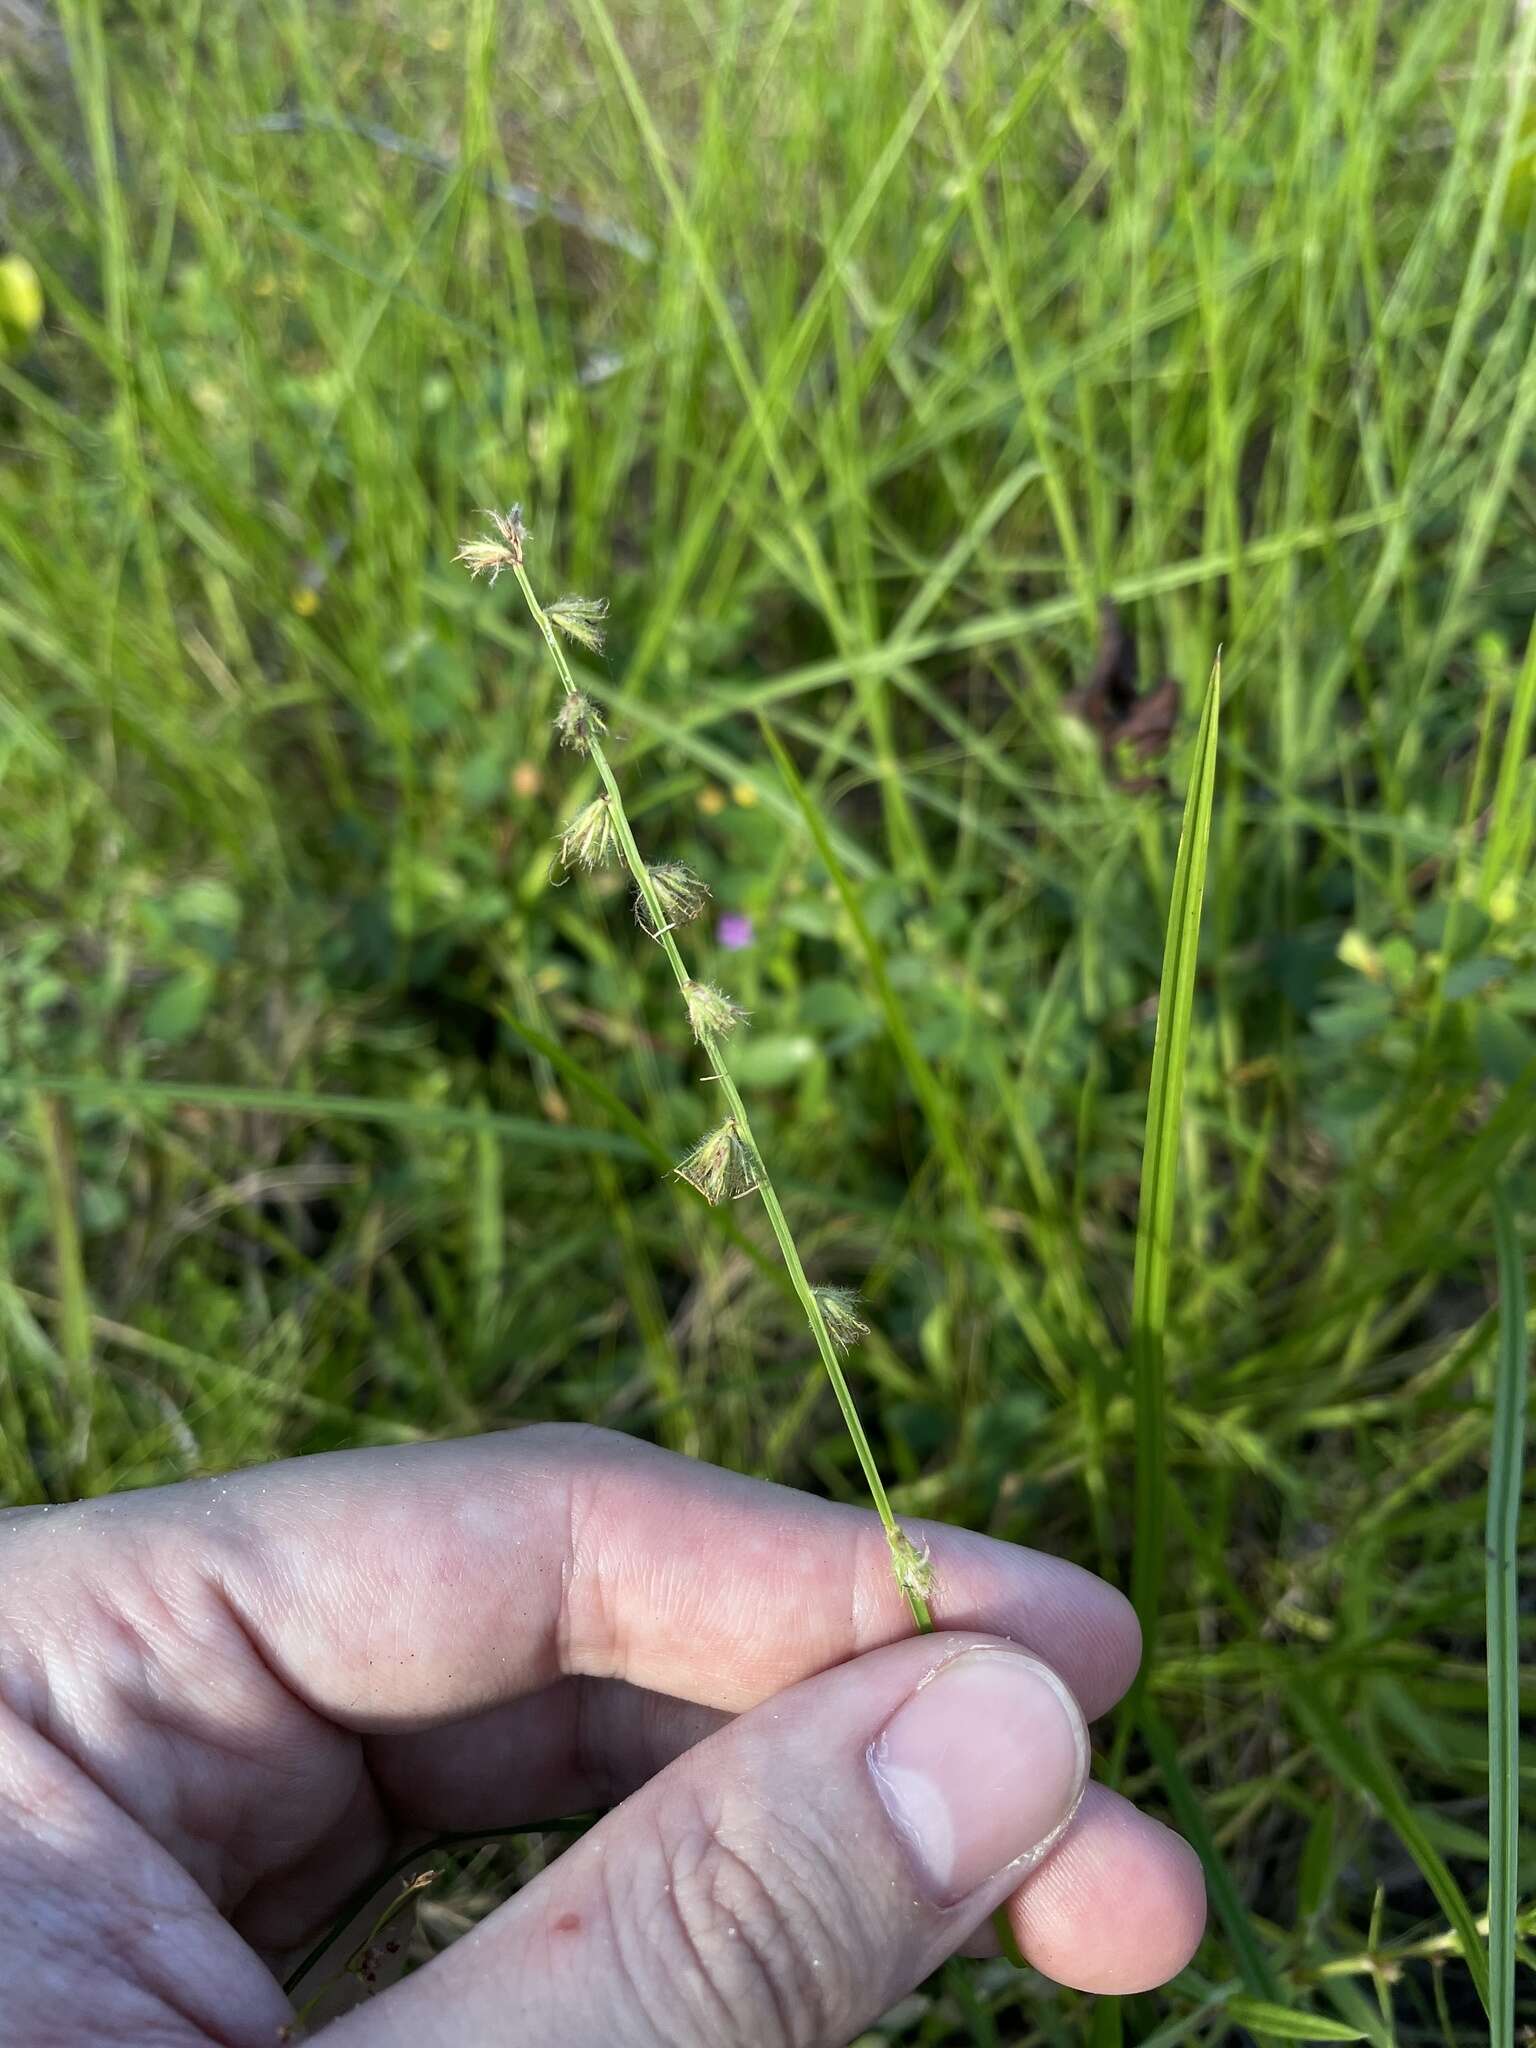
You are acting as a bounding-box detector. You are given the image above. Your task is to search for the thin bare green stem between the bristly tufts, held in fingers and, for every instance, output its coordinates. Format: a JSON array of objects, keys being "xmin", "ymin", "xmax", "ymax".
[{"xmin": 508, "ymin": 561, "xmax": 934, "ymax": 1634}]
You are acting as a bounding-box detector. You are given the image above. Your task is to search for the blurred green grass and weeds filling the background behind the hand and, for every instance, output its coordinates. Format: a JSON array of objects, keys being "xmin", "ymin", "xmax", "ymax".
[{"xmin": 0, "ymin": 0, "xmax": 1536, "ymax": 2044}]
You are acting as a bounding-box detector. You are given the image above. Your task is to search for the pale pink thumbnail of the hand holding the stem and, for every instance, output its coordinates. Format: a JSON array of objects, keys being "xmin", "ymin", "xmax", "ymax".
[{"xmin": 868, "ymin": 1649, "xmax": 1087, "ymax": 1905}]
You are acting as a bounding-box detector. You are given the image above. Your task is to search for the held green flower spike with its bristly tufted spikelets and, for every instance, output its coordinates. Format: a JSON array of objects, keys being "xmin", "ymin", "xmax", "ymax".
[{"xmin": 457, "ymin": 506, "xmax": 934, "ymax": 1634}]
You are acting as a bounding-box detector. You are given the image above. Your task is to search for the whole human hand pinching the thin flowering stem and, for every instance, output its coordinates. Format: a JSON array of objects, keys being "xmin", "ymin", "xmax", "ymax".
[{"xmin": 0, "ymin": 1425, "xmax": 1204, "ymax": 2048}]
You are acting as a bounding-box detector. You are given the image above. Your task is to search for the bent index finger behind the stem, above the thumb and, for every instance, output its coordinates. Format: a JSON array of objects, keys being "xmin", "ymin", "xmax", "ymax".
[{"xmin": 55, "ymin": 1423, "xmax": 1139, "ymax": 1731}]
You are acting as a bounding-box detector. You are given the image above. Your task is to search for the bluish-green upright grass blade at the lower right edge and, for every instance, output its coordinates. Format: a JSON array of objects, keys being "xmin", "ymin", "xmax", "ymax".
[{"xmin": 1487, "ymin": 1186, "xmax": 1530, "ymax": 2048}]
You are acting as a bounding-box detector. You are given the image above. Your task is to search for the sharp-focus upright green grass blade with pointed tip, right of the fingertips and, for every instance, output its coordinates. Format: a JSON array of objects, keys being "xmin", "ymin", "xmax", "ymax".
[{"xmin": 1130, "ymin": 653, "xmax": 1221, "ymax": 1683}]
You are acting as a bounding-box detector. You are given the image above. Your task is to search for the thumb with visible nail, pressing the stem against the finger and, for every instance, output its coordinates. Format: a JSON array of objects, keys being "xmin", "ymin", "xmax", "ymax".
[{"xmin": 326, "ymin": 1636, "xmax": 1087, "ymax": 2048}]
